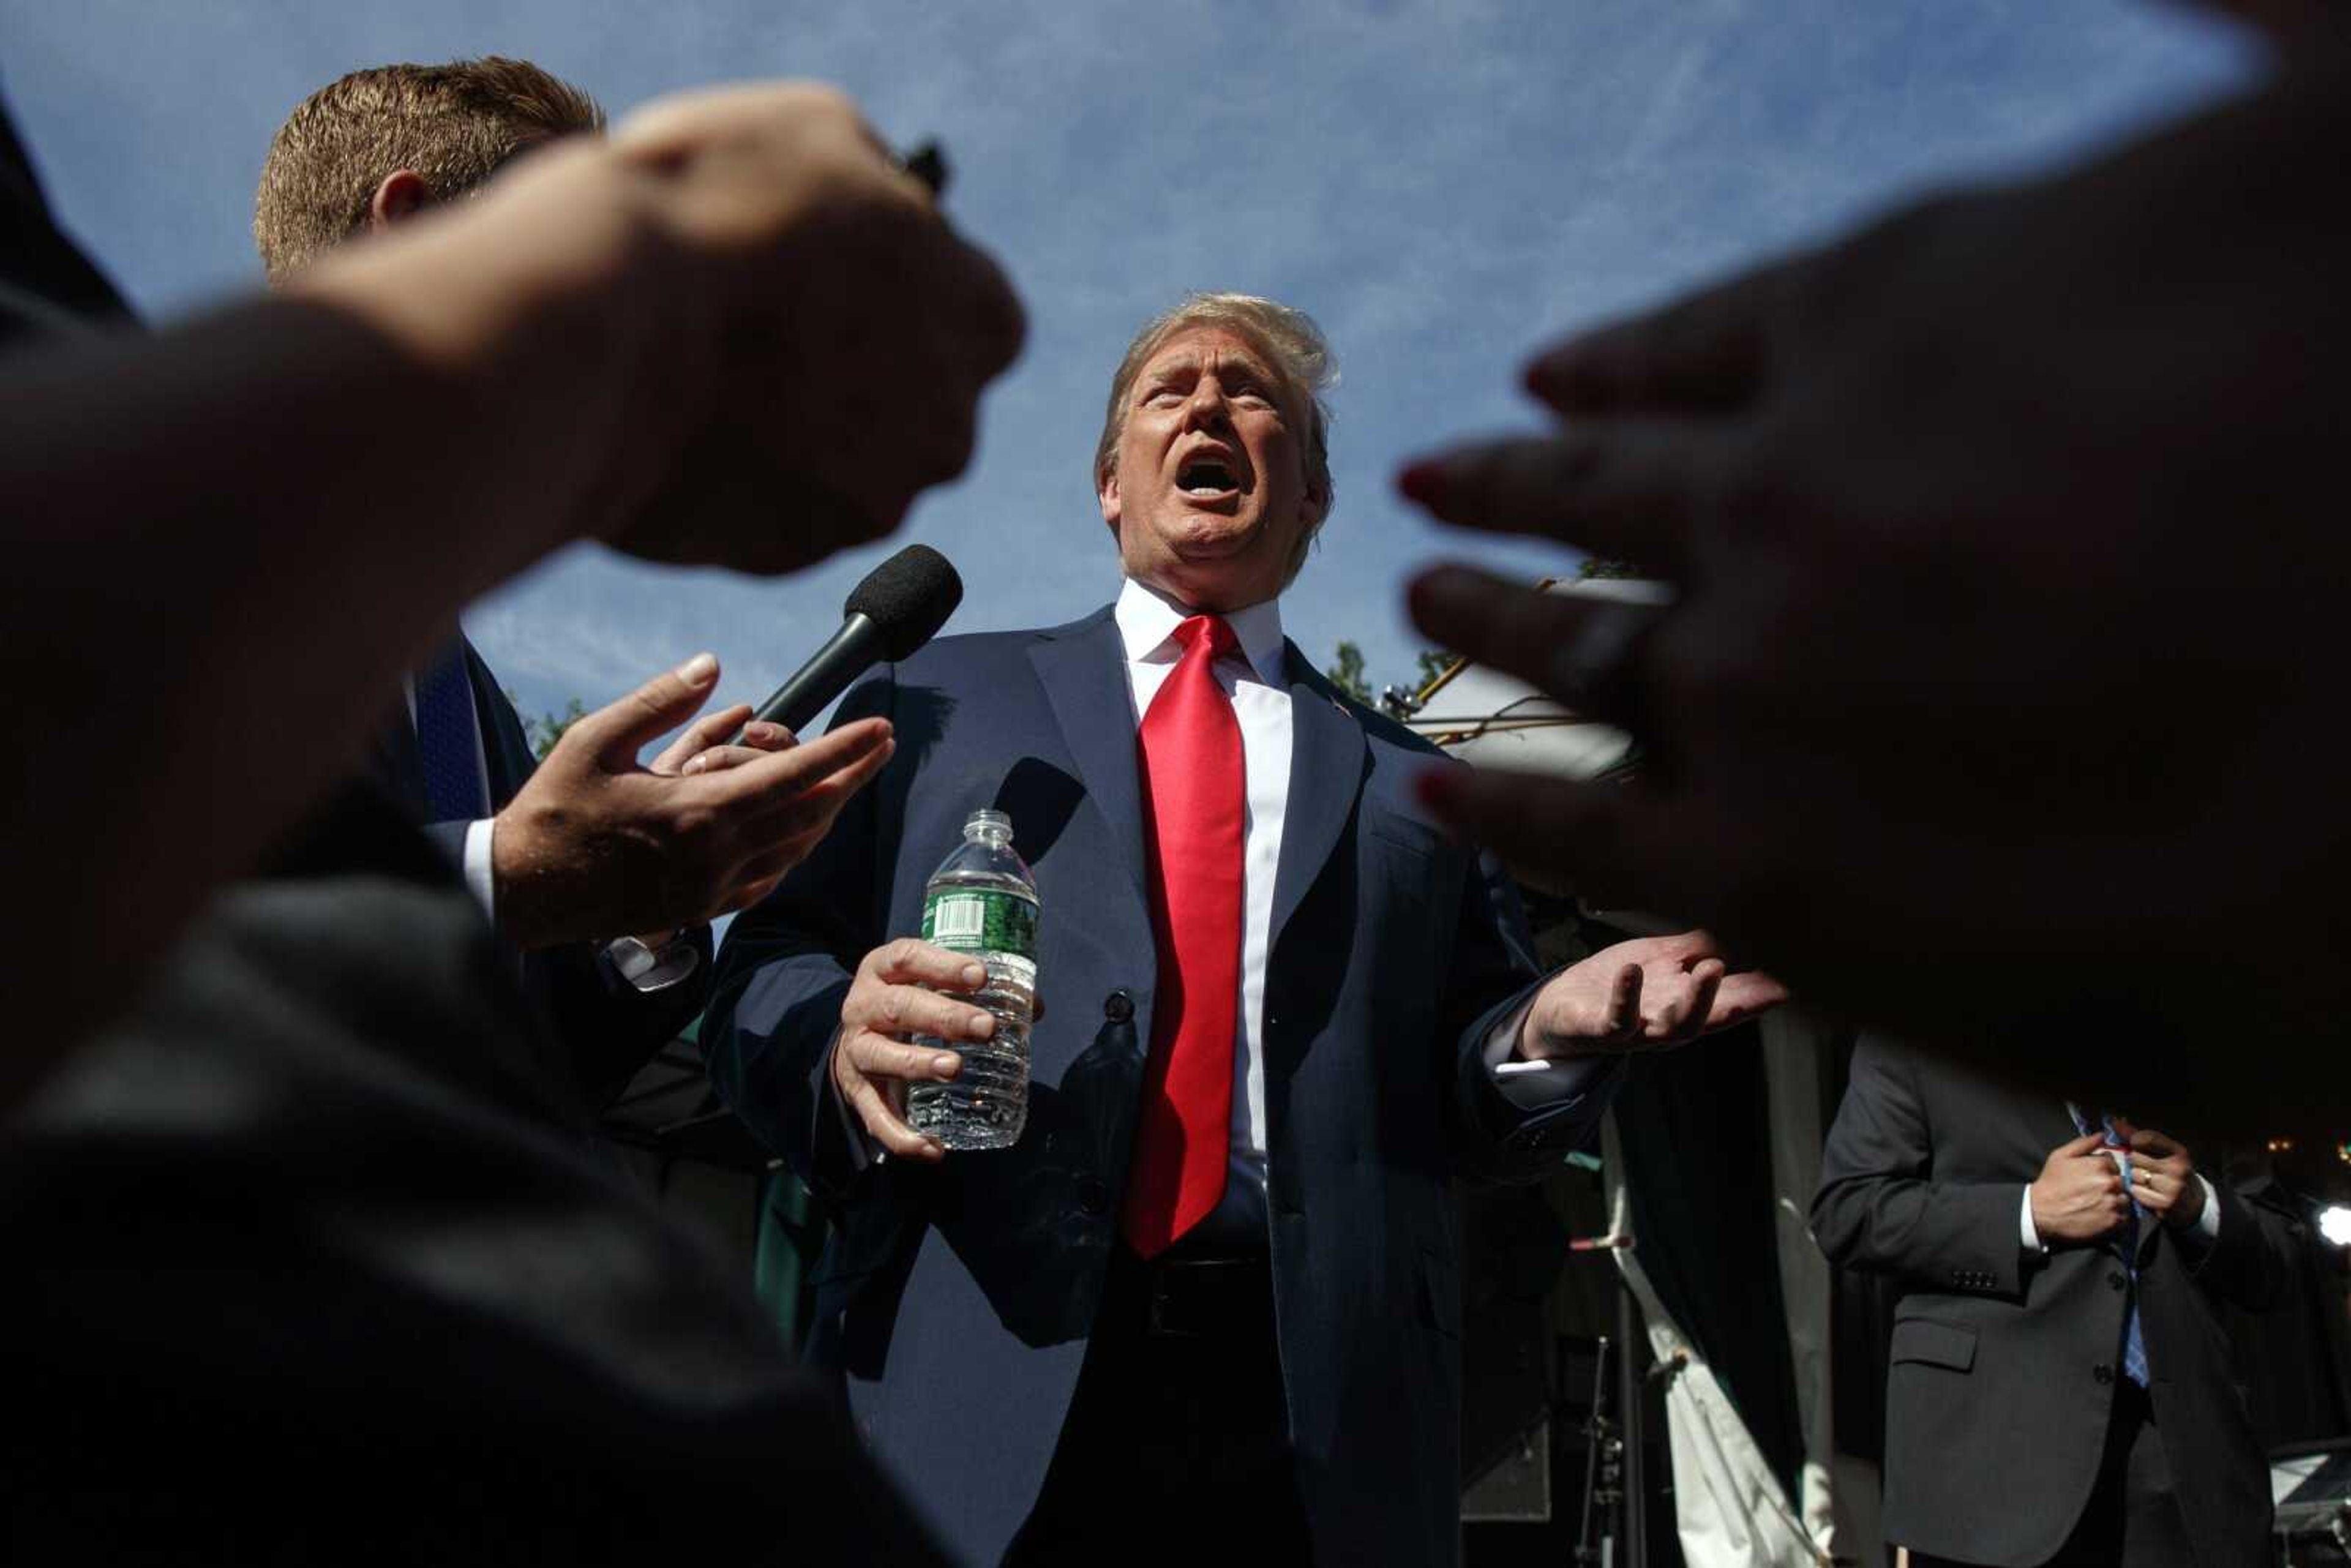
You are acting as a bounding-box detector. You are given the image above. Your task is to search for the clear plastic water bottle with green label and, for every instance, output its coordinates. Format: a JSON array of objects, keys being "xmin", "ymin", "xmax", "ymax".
[{"xmin": 905, "ymin": 811, "xmax": 1037, "ymax": 1150}]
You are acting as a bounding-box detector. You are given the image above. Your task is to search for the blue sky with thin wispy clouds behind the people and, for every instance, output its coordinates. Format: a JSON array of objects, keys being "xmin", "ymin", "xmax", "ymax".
[{"xmin": 0, "ymin": 0, "xmax": 2255, "ymax": 738}]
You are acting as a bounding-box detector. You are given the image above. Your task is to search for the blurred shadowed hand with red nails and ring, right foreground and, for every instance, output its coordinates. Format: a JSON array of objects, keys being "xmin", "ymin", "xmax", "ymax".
[{"xmin": 1399, "ymin": 68, "xmax": 2351, "ymax": 1107}]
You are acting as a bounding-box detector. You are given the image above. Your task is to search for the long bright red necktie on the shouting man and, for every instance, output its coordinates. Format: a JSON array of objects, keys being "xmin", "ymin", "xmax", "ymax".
[{"xmin": 1119, "ymin": 616, "xmax": 1248, "ymax": 1258}]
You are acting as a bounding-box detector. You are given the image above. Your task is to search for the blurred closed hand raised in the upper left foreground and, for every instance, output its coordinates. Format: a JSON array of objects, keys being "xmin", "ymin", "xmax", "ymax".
[{"xmin": 287, "ymin": 82, "xmax": 1022, "ymax": 583}]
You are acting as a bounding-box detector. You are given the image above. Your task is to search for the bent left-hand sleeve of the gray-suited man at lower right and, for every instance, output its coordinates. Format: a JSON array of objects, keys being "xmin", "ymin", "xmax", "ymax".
[{"xmin": 1813, "ymin": 1039, "xmax": 2024, "ymax": 1296}]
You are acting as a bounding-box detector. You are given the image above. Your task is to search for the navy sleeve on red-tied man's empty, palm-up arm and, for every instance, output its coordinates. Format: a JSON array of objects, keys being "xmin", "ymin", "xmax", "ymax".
[{"xmin": 1444, "ymin": 856, "xmax": 1620, "ymax": 1182}]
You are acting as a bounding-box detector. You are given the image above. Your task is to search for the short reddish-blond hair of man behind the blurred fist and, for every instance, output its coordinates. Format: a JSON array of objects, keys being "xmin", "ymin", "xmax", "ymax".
[{"xmin": 254, "ymin": 54, "xmax": 604, "ymax": 282}]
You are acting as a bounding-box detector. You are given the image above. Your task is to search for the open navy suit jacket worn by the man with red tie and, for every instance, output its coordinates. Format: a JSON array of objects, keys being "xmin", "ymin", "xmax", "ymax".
[{"xmin": 703, "ymin": 609, "xmax": 1603, "ymax": 1566}]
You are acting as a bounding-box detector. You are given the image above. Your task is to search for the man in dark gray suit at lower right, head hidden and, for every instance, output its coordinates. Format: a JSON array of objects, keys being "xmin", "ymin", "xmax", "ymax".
[{"xmin": 1813, "ymin": 1039, "xmax": 2292, "ymax": 1568}]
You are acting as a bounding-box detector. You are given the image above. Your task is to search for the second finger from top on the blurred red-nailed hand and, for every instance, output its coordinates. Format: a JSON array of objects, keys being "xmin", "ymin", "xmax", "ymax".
[{"xmin": 1397, "ymin": 421, "xmax": 1719, "ymax": 576}]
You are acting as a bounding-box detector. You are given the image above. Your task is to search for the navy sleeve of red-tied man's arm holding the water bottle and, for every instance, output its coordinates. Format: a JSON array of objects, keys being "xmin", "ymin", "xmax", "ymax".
[{"xmin": 703, "ymin": 666, "xmax": 898, "ymax": 1196}]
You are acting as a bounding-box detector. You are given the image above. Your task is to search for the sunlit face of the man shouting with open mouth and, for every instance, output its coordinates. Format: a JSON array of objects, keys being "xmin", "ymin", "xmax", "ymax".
[{"xmin": 1100, "ymin": 327, "xmax": 1324, "ymax": 611}]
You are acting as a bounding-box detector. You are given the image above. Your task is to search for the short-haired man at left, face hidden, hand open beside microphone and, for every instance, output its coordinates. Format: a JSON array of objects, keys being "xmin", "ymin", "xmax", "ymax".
[{"xmin": 254, "ymin": 56, "xmax": 823, "ymax": 1114}]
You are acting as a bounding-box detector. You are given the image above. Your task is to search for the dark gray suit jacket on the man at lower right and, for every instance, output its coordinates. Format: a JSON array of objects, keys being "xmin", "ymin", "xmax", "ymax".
[{"xmin": 1813, "ymin": 1039, "xmax": 2292, "ymax": 1568}]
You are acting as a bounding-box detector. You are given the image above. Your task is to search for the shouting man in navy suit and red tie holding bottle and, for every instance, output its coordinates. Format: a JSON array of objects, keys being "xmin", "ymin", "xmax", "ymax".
[{"xmin": 703, "ymin": 294, "xmax": 1777, "ymax": 1563}]
